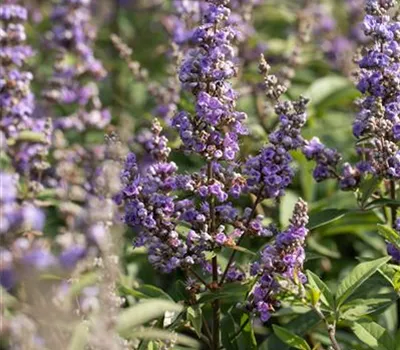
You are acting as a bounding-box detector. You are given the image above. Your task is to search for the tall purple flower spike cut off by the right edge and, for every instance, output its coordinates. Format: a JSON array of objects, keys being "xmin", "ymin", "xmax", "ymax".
[{"xmin": 352, "ymin": 0, "xmax": 400, "ymax": 179}]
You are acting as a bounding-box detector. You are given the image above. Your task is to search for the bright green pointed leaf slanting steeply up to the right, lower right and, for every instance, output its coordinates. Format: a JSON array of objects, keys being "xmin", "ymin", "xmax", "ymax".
[{"xmin": 336, "ymin": 257, "xmax": 390, "ymax": 307}]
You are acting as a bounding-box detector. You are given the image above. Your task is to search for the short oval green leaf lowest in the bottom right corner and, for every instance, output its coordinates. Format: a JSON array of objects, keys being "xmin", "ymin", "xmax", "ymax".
[{"xmin": 351, "ymin": 321, "xmax": 395, "ymax": 350}]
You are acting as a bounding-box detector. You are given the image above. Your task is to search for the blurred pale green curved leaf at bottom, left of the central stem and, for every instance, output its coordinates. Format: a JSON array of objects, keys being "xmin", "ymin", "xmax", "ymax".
[{"xmin": 116, "ymin": 299, "xmax": 183, "ymax": 335}]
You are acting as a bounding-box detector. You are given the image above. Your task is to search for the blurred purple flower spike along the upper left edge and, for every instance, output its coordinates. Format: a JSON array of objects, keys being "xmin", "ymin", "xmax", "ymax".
[{"xmin": 0, "ymin": 0, "xmax": 50, "ymax": 178}]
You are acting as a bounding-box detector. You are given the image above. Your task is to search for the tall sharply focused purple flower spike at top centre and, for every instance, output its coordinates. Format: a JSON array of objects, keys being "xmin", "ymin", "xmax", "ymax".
[{"xmin": 172, "ymin": 3, "xmax": 247, "ymax": 161}]
